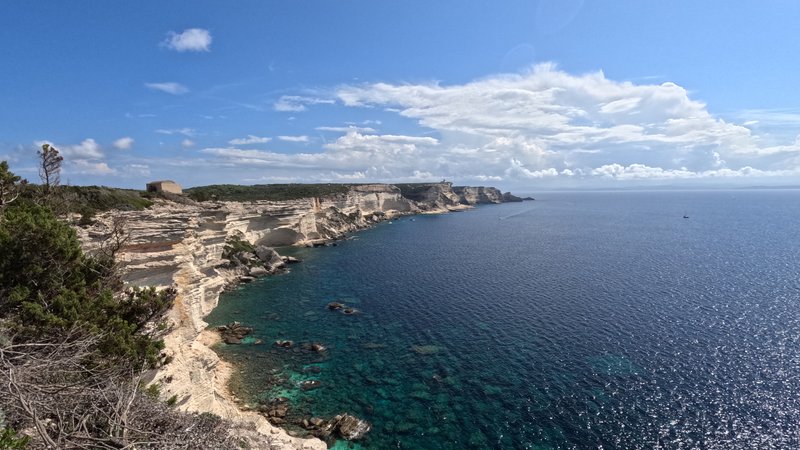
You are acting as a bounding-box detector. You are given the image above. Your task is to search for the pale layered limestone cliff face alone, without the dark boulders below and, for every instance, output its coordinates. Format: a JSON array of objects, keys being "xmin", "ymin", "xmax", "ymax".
[{"xmin": 79, "ymin": 185, "xmax": 520, "ymax": 449}]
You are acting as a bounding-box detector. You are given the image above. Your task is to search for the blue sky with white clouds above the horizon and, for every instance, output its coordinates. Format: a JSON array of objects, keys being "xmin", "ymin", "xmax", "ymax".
[{"xmin": 0, "ymin": 0, "xmax": 800, "ymax": 192}]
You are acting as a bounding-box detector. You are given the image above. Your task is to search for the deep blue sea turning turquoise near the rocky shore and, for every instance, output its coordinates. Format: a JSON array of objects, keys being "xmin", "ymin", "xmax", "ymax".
[{"xmin": 208, "ymin": 190, "xmax": 800, "ymax": 449}]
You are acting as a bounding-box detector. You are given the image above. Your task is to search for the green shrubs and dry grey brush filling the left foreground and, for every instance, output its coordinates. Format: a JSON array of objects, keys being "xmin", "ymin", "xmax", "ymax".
[{"xmin": 0, "ymin": 150, "xmax": 276, "ymax": 449}]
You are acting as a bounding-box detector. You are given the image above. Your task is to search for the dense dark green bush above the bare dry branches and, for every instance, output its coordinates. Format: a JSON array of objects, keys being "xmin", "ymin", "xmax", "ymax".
[{"xmin": 0, "ymin": 203, "xmax": 175, "ymax": 365}]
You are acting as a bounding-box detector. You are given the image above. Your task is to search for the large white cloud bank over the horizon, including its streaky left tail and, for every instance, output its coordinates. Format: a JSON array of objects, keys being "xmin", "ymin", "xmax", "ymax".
[{"xmin": 87, "ymin": 64, "xmax": 800, "ymax": 187}]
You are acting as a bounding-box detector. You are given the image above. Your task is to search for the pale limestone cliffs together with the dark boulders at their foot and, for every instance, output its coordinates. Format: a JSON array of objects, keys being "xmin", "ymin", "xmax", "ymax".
[{"xmin": 78, "ymin": 183, "xmax": 521, "ymax": 449}]
